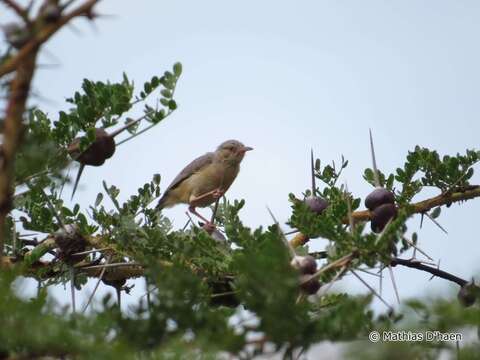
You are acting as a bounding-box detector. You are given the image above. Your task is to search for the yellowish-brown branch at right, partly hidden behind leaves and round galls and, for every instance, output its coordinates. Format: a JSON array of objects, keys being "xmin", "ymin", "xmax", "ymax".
[{"xmin": 290, "ymin": 185, "xmax": 480, "ymax": 247}]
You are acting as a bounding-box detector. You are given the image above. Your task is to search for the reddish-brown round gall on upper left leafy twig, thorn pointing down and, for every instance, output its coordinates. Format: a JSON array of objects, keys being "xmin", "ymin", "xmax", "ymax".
[{"xmin": 67, "ymin": 129, "xmax": 115, "ymax": 166}]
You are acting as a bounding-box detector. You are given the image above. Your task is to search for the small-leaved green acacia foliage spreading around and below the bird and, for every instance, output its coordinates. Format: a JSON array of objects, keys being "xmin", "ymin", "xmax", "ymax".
[{"xmin": 0, "ymin": 63, "xmax": 480, "ymax": 359}]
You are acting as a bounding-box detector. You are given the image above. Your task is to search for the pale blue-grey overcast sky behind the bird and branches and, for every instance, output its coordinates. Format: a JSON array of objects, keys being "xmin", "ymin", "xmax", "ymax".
[{"xmin": 1, "ymin": 0, "xmax": 480, "ymax": 352}]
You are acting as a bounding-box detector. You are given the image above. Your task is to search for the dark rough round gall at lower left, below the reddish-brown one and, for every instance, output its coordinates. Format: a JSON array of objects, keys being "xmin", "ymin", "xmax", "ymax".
[{"xmin": 54, "ymin": 224, "xmax": 87, "ymax": 264}]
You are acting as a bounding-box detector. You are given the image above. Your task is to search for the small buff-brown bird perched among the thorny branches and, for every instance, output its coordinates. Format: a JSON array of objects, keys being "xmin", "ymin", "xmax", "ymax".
[{"xmin": 156, "ymin": 140, "xmax": 253, "ymax": 226}]
